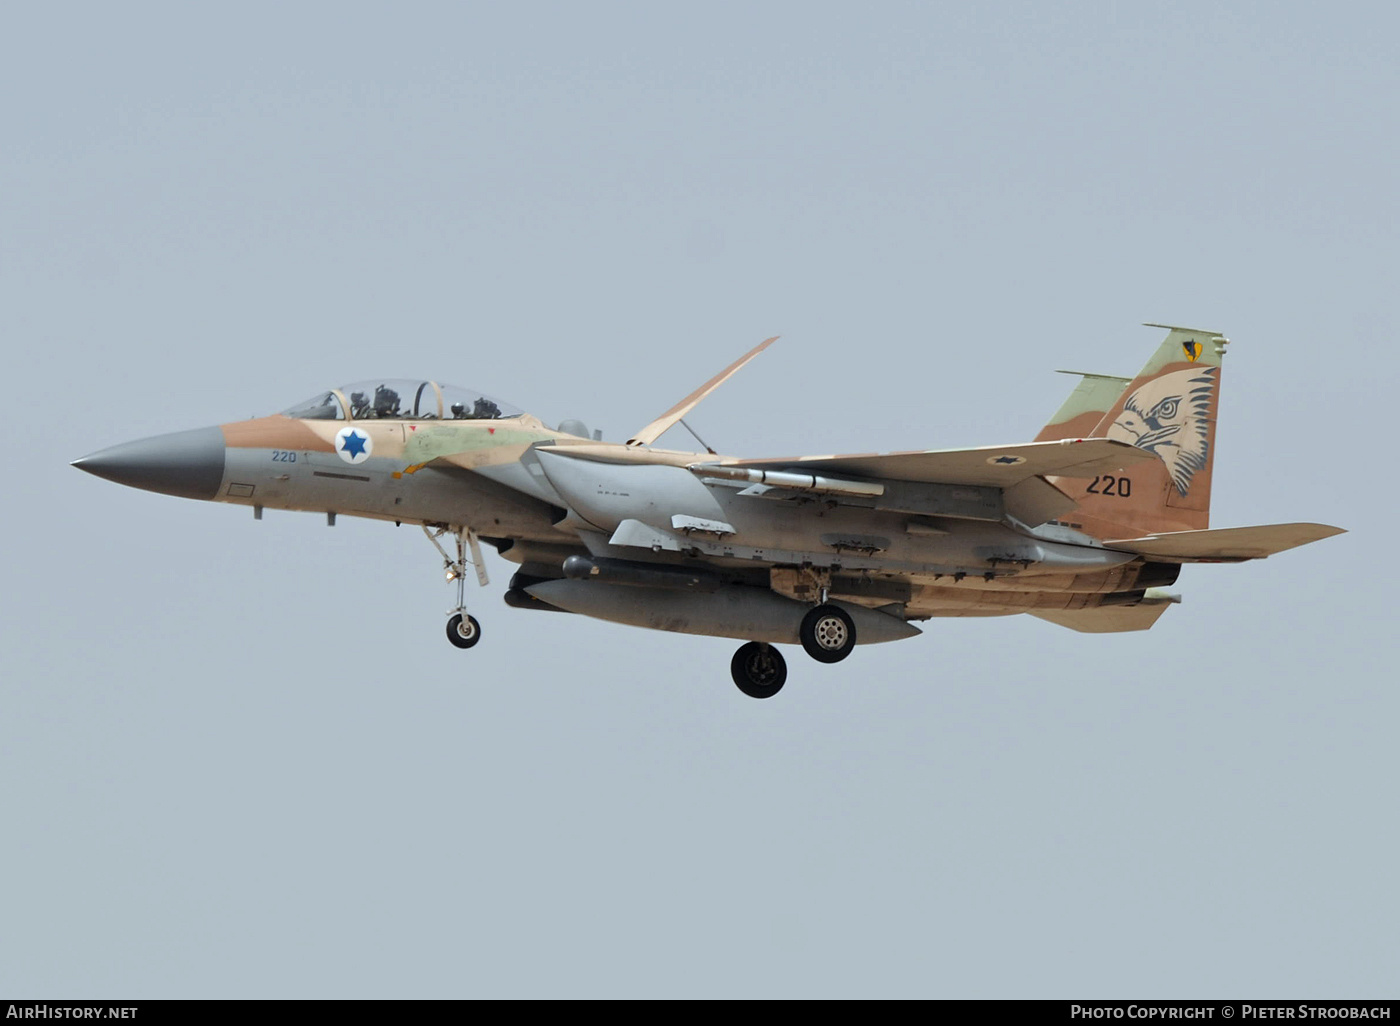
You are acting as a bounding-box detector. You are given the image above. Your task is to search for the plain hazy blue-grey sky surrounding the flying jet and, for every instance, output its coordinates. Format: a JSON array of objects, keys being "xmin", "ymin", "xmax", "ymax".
[{"xmin": 0, "ymin": 3, "xmax": 1400, "ymax": 998}]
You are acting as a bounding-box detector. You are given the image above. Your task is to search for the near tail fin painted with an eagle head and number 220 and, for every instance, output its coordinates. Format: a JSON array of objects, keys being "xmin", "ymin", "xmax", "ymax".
[{"xmin": 1054, "ymin": 325, "xmax": 1229, "ymax": 537}]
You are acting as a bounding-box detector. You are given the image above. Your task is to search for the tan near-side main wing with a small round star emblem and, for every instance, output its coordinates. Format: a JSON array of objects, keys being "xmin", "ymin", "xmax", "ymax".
[{"xmin": 725, "ymin": 438, "xmax": 1156, "ymax": 489}]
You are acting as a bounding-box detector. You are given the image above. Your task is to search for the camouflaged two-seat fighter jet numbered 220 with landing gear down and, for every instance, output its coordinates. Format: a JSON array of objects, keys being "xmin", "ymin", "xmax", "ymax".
[{"xmin": 73, "ymin": 325, "xmax": 1341, "ymax": 698}]
